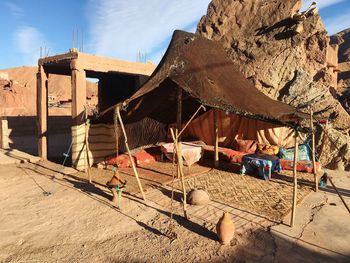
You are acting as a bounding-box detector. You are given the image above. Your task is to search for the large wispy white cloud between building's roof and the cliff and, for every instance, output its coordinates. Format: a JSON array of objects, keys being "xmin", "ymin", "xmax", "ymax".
[{"xmin": 87, "ymin": 0, "xmax": 210, "ymax": 62}]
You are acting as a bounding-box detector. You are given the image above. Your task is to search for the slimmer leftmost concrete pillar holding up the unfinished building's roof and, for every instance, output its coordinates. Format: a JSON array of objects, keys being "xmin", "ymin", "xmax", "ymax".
[{"xmin": 36, "ymin": 66, "xmax": 48, "ymax": 160}]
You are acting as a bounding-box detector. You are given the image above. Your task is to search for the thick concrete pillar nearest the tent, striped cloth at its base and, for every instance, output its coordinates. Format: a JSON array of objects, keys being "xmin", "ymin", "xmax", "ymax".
[{"xmin": 71, "ymin": 60, "xmax": 86, "ymax": 170}]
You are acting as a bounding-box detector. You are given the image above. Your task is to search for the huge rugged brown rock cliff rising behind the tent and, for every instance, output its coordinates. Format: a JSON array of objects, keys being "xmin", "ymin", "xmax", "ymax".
[{"xmin": 197, "ymin": 0, "xmax": 350, "ymax": 169}]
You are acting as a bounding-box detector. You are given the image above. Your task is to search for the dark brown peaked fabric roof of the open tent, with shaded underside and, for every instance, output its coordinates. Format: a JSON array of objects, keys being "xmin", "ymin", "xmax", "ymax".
[{"xmin": 99, "ymin": 30, "xmax": 308, "ymax": 126}]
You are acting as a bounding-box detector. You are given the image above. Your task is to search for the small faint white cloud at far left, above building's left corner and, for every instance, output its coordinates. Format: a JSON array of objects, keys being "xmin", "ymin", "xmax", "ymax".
[{"xmin": 13, "ymin": 26, "xmax": 48, "ymax": 65}]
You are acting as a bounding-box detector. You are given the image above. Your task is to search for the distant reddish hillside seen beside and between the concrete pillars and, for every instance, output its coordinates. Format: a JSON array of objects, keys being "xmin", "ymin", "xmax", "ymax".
[{"xmin": 0, "ymin": 67, "xmax": 97, "ymax": 116}]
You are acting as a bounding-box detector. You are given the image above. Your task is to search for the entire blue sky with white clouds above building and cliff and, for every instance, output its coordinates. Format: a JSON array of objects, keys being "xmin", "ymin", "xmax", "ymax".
[{"xmin": 0, "ymin": 0, "xmax": 350, "ymax": 68}]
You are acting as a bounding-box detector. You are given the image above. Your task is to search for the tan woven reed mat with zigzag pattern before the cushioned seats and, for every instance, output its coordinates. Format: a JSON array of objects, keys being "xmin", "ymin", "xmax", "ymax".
[{"xmin": 174, "ymin": 169, "xmax": 313, "ymax": 221}]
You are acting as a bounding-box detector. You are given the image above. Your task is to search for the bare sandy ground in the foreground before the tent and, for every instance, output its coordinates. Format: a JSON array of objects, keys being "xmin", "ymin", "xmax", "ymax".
[{"xmin": 0, "ymin": 160, "xmax": 350, "ymax": 262}]
